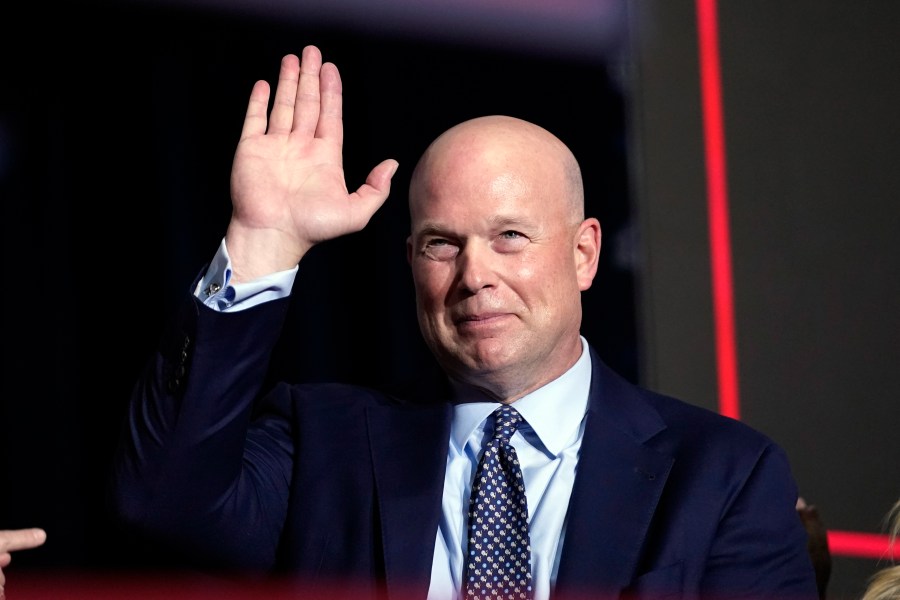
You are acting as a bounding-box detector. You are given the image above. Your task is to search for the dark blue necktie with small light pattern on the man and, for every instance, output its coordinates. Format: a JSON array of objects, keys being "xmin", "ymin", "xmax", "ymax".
[{"xmin": 463, "ymin": 404, "xmax": 534, "ymax": 600}]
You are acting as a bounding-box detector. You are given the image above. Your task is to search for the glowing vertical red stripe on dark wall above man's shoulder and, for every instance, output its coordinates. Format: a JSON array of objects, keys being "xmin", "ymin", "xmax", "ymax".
[{"xmin": 697, "ymin": 0, "xmax": 740, "ymax": 419}]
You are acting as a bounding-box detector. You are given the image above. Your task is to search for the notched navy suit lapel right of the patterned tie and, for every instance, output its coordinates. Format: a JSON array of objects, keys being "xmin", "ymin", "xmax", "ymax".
[{"xmin": 556, "ymin": 351, "xmax": 674, "ymax": 597}]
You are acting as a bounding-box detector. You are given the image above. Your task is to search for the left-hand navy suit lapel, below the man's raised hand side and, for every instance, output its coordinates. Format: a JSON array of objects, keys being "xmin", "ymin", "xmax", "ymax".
[{"xmin": 368, "ymin": 404, "xmax": 451, "ymax": 598}]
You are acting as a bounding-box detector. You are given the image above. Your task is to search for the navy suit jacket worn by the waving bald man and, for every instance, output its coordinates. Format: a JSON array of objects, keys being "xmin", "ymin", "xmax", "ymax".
[{"xmin": 112, "ymin": 297, "xmax": 817, "ymax": 600}]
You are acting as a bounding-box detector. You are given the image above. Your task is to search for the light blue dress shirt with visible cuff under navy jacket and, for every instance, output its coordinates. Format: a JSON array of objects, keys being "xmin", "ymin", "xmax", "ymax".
[{"xmin": 194, "ymin": 239, "xmax": 591, "ymax": 600}]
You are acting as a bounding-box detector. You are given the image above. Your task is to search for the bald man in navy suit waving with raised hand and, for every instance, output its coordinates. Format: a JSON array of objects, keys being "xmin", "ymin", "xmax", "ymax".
[{"xmin": 114, "ymin": 46, "xmax": 816, "ymax": 600}]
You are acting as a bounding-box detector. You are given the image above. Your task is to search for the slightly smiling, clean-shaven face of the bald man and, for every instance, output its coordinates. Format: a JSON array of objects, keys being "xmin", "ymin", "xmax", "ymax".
[{"xmin": 407, "ymin": 118, "xmax": 599, "ymax": 400}]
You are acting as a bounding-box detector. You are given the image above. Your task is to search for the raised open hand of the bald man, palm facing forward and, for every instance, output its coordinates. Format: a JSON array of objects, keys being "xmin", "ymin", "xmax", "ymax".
[{"xmin": 225, "ymin": 46, "xmax": 397, "ymax": 281}]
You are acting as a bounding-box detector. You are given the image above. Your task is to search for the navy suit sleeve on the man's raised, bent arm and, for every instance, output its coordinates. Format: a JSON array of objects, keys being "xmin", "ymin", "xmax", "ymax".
[{"xmin": 110, "ymin": 296, "xmax": 292, "ymax": 570}]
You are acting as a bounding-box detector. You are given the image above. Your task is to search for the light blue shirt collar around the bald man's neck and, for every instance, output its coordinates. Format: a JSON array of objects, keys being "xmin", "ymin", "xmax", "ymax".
[{"xmin": 450, "ymin": 337, "xmax": 591, "ymax": 455}]
